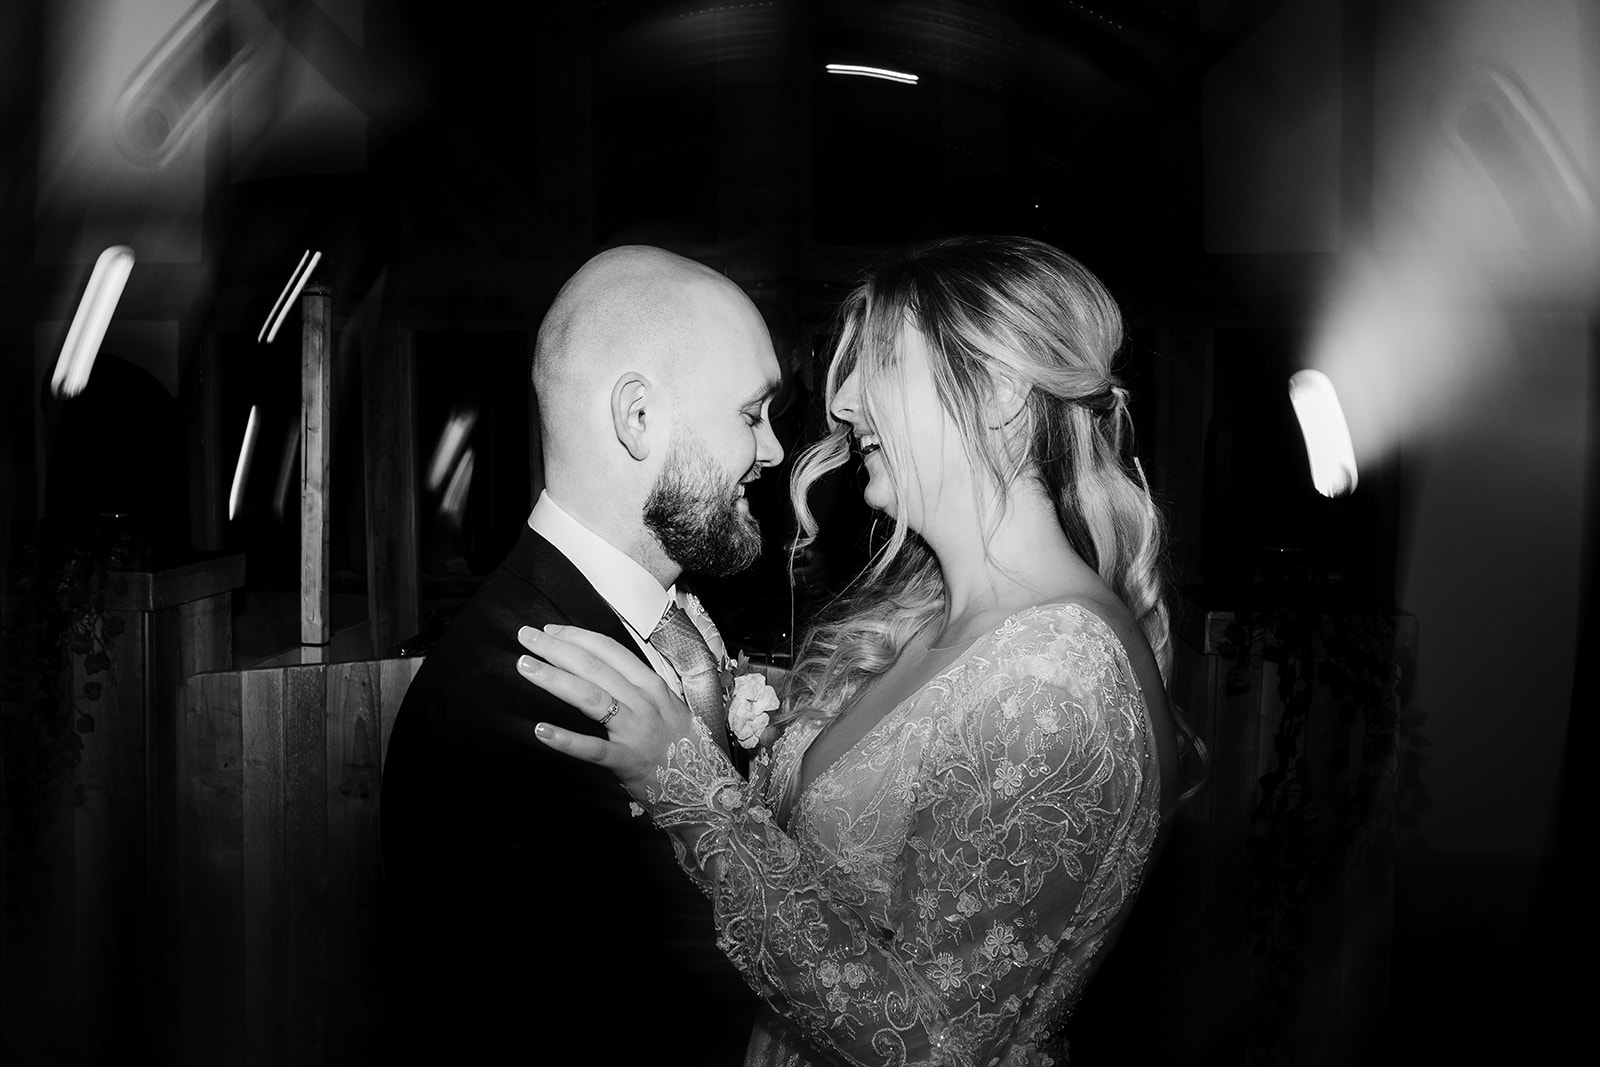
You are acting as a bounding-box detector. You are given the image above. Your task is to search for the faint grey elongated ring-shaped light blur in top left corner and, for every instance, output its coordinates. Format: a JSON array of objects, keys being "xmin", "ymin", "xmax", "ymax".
[{"xmin": 112, "ymin": 0, "xmax": 258, "ymax": 168}]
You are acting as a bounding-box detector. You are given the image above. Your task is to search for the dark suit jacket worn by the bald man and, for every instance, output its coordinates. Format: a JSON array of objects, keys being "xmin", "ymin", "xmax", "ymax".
[{"xmin": 381, "ymin": 530, "xmax": 755, "ymax": 1064}]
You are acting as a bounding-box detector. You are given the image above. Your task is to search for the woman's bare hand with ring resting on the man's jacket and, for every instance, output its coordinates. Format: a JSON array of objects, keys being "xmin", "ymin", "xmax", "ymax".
[{"xmin": 517, "ymin": 625, "xmax": 694, "ymax": 798}]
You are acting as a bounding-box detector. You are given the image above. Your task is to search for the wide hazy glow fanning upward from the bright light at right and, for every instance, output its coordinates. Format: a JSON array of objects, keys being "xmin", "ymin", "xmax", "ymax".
[{"xmin": 1307, "ymin": 36, "xmax": 1600, "ymax": 467}]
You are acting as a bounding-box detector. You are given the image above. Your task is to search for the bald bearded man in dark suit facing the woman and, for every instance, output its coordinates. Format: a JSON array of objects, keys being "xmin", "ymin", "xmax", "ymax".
[{"xmin": 382, "ymin": 246, "xmax": 782, "ymax": 1064}]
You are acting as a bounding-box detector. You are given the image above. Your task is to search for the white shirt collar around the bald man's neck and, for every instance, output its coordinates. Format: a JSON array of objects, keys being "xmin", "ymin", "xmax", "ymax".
[{"xmin": 528, "ymin": 493, "xmax": 726, "ymax": 697}]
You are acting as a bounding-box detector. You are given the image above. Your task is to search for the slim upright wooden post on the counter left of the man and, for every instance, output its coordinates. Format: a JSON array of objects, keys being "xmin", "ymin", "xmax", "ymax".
[{"xmin": 301, "ymin": 285, "xmax": 333, "ymax": 645}]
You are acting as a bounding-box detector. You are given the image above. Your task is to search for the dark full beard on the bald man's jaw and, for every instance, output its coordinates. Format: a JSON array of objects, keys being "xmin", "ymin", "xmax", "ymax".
[{"xmin": 645, "ymin": 438, "xmax": 762, "ymax": 577}]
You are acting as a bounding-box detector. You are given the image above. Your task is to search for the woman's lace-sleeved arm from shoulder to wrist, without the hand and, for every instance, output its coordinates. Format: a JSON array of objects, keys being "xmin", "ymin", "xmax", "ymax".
[{"xmin": 518, "ymin": 607, "xmax": 1155, "ymax": 1064}]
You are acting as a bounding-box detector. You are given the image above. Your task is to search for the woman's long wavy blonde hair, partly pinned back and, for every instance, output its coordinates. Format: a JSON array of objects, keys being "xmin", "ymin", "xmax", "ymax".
[{"xmin": 781, "ymin": 237, "xmax": 1171, "ymax": 735}]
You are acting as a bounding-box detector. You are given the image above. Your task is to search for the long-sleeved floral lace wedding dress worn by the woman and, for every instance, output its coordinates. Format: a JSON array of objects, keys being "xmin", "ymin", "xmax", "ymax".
[{"xmin": 646, "ymin": 605, "xmax": 1160, "ymax": 1067}]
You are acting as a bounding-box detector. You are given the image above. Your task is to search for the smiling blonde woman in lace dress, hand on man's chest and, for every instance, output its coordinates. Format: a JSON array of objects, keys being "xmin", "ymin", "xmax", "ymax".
[{"xmin": 518, "ymin": 237, "xmax": 1179, "ymax": 1065}]
